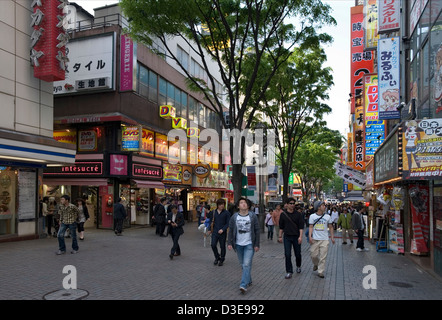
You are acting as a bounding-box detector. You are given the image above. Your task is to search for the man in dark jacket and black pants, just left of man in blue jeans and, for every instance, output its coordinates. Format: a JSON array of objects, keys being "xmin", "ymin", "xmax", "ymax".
[{"xmin": 209, "ymin": 199, "xmax": 230, "ymax": 266}]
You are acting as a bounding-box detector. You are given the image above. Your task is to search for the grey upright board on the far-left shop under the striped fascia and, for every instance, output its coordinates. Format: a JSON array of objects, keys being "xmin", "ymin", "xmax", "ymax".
[{"xmin": 17, "ymin": 170, "xmax": 37, "ymax": 220}]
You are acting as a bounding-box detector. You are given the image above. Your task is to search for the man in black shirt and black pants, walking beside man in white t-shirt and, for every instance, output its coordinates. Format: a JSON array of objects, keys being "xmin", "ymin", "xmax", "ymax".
[{"xmin": 279, "ymin": 198, "xmax": 304, "ymax": 279}]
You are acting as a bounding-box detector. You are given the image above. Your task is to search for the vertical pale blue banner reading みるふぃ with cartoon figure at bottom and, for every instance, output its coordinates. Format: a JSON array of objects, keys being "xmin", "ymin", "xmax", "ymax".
[{"xmin": 378, "ymin": 37, "xmax": 401, "ymax": 119}]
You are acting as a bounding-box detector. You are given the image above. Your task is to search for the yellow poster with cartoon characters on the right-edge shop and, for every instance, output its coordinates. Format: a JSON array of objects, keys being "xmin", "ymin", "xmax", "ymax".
[{"xmin": 402, "ymin": 119, "xmax": 442, "ymax": 180}]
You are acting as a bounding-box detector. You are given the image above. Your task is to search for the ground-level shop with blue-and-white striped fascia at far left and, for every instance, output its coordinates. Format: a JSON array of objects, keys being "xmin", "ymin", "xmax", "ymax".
[{"xmin": 0, "ymin": 130, "xmax": 75, "ymax": 241}]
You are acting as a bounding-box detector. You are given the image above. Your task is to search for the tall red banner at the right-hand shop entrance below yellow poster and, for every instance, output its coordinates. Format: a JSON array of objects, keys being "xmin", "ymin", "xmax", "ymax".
[{"xmin": 408, "ymin": 184, "xmax": 430, "ymax": 254}]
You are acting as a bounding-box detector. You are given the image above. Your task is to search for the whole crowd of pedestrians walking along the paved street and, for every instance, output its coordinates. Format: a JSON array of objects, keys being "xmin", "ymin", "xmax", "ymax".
[{"xmin": 47, "ymin": 195, "xmax": 368, "ymax": 293}]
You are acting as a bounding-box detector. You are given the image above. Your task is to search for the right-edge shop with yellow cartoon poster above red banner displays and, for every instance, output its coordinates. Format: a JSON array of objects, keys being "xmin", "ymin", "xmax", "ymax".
[{"xmin": 373, "ymin": 119, "xmax": 442, "ymax": 274}]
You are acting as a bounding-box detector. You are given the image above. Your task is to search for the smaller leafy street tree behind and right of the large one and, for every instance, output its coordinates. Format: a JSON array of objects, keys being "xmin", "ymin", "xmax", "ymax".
[{"xmin": 262, "ymin": 46, "xmax": 333, "ymax": 201}]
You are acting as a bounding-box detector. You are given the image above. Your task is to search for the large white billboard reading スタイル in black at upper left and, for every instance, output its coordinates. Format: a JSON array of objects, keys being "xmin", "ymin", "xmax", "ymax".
[{"xmin": 54, "ymin": 33, "xmax": 115, "ymax": 95}]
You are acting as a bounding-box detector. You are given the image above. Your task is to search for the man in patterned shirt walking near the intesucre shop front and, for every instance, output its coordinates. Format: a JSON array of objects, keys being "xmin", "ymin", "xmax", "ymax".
[{"xmin": 56, "ymin": 195, "xmax": 80, "ymax": 255}]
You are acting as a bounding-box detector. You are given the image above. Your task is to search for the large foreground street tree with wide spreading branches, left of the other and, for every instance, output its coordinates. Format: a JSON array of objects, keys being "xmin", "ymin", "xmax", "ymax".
[{"xmin": 120, "ymin": 0, "xmax": 336, "ymax": 201}]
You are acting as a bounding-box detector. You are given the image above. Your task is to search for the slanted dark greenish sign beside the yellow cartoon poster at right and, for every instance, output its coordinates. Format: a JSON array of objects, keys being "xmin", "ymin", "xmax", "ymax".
[{"xmin": 374, "ymin": 133, "xmax": 399, "ymax": 183}]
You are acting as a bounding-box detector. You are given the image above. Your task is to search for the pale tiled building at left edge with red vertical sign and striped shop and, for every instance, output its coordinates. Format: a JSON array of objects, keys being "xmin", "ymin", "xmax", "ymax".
[{"xmin": 0, "ymin": 0, "xmax": 76, "ymax": 241}]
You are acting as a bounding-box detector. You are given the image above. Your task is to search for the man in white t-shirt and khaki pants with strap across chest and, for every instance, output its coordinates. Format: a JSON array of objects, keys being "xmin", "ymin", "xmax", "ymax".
[{"xmin": 309, "ymin": 201, "xmax": 335, "ymax": 278}]
